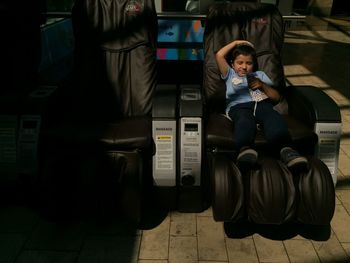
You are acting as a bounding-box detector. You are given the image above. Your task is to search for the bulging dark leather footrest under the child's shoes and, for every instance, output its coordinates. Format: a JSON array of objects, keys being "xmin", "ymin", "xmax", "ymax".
[{"xmin": 208, "ymin": 153, "xmax": 335, "ymax": 225}]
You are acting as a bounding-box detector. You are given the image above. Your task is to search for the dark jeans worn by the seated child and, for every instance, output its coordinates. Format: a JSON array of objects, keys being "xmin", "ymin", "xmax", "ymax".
[{"xmin": 229, "ymin": 100, "xmax": 291, "ymax": 155}]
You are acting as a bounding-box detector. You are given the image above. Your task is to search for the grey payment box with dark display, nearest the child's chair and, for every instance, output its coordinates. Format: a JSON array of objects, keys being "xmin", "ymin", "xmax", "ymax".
[{"xmin": 178, "ymin": 85, "xmax": 203, "ymax": 212}]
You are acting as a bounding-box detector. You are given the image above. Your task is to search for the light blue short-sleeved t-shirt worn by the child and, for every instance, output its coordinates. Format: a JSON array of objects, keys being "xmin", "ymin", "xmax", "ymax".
[{"xmin": 221, "ymin": 68, "xmax": 273, "ymax": 112}]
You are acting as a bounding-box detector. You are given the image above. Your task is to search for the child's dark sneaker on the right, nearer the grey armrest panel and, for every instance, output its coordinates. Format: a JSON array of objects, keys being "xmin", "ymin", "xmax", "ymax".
[{"xmin": 280, "ymin": 147, "xmax": 308, "ymax": 171}]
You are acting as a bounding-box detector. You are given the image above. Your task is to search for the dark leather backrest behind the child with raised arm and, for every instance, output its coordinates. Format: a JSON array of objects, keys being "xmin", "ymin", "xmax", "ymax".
[{"xmin": 203, "ymin": 2, "xmax": 286, "ymax": 112}]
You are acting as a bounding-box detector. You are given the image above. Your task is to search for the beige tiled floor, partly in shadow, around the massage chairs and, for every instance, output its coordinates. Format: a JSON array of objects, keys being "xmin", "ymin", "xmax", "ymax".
[{"xmin": 0, "ymin": 18, "xmax": 350, "ymax": 263}]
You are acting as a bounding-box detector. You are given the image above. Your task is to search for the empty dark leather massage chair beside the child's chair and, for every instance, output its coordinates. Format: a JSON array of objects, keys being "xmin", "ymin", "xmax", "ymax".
[{"xmin": 39, "ymin": 0, "xmax": 158, "ymax": 222}]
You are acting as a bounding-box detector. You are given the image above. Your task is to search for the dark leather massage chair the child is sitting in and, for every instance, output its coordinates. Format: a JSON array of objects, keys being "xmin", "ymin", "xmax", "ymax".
[{"xmin": 203, "ymin": 2, "xmax": 341, "ymax": 226}]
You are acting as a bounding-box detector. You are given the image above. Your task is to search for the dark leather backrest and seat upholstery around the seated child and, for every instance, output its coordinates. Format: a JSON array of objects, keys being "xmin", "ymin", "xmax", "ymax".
[{"xmin": 204, "ymin": 3, "xmax": 324, "ymax": 157}]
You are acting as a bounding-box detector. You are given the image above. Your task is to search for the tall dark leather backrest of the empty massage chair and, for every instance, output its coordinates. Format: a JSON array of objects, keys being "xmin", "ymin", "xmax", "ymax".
[{"xmin": 72, "ymin": 0, "xmax": 158, "ymax": 120}]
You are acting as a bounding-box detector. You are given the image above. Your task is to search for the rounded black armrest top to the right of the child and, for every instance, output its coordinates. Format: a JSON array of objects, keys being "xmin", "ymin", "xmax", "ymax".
[{"xmin": 287, "ymin": 86, "xmax": 341, "ymax": 125}]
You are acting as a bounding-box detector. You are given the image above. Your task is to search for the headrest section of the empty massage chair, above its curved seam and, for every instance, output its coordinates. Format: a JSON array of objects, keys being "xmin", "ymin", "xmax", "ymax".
[{"xmin": 72, "ymin": 0, "xmax": 157, "ymax": 51}]
